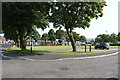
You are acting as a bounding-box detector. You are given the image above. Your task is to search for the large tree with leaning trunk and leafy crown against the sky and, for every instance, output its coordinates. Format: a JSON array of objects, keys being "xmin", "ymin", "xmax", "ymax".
[{"xmin": 51, "ymin": 2, "xmax": 106, "ymax": 51}]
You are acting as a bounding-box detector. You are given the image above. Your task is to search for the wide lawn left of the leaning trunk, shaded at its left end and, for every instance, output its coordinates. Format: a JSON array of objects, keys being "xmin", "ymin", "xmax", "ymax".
[{"xmin": 4, "ymin": 46, "xmax": 71, "ymax": 55}]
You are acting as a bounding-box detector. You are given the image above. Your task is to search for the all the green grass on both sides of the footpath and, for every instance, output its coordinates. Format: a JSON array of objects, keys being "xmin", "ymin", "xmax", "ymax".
[{"xmin": 4, "ymin": 46, "xmax": 120, "ymax": 55}]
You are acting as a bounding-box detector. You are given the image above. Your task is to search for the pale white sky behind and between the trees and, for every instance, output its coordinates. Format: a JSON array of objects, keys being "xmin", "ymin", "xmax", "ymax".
[{"xmin": 37, "ymin": 0, "xmax": 120, "ymax": 38}]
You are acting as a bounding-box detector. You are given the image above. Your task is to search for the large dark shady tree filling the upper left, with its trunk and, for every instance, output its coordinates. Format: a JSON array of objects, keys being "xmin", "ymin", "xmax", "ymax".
[{"xmin": 2, "ymin": 2, "xmax": 49, "ymax": 50}]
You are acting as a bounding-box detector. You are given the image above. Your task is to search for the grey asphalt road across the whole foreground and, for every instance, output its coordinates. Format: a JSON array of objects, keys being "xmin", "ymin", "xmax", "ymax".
[{"xmin": 0, "ymin": 43, "xmax": 118, "ymax": 78}]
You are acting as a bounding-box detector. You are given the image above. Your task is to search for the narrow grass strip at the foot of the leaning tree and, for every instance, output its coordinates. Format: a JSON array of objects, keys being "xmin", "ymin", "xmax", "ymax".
[{"xmin": 57, "ymin": 49, "xmax": 108, "ymax": 55}]
